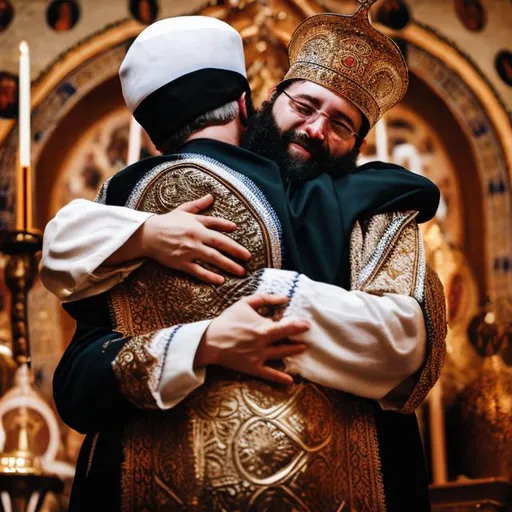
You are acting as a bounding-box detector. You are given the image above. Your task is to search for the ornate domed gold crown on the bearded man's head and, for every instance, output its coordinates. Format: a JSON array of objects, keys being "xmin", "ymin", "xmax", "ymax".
[{"xmin": 284, "ymin": 0, "xmax": 409, "ymax": 127}]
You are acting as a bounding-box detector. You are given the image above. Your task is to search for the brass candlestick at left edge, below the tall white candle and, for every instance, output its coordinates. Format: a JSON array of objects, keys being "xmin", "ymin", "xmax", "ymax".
[{"xmin": 0, "ymin": 230, "xmax": 64, "ymax": 512}]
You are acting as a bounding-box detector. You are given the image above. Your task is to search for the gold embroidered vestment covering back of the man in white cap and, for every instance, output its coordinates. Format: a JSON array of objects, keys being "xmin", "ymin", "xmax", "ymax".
[{"xmin": 110, "ymin": 158, "xmax": 385, "ymax": 512}]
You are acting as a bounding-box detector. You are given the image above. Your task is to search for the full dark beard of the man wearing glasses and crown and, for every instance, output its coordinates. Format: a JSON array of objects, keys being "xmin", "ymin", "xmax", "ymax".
[{"xmin": 241, "ymin": 96, "xmax": 360, "ymax": 185}]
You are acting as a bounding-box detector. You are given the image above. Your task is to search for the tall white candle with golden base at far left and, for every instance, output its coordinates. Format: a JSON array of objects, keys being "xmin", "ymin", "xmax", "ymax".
[{"xmin": 16, "ymin": 41, "xmax": 32, "ymax": 231}]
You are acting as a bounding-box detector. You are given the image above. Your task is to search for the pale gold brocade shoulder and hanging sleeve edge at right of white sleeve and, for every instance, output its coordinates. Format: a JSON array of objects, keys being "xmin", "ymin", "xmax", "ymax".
[{"xmin": 352, "ymin": 212, "xmax": 447, "ymax": 413}]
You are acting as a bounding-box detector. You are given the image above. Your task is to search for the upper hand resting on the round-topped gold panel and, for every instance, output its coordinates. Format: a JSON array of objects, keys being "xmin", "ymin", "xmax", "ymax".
[{"xmin": 140, "ymin": 194, "xmax": 251, "ymax": 284}]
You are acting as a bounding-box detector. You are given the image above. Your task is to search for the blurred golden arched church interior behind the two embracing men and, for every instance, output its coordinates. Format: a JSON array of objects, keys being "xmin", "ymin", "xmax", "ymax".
[{"xmin": 0, "ymin": 0, "xmax": 512, "ymax": 511}]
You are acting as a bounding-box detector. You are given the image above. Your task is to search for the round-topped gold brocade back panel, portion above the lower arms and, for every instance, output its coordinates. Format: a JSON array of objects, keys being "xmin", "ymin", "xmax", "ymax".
[{"xmin": 110, "ymin": 161, "xmax": 280, "ymax": 335}]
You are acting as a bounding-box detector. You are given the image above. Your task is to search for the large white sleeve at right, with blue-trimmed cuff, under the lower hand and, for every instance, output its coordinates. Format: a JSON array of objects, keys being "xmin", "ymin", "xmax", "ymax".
[{"xmin": 254, "ymin": 269, "xmax": 426, "ymax": 408}]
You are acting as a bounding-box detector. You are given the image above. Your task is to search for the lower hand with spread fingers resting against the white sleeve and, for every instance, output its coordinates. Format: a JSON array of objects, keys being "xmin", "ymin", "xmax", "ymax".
[{"xmin": 194, "ymin": 294, "xmax": 310, "ymax": 384}]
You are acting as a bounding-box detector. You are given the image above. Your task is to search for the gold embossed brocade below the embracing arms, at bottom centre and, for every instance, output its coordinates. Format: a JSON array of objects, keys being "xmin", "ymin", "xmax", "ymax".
[{"xmin": 123, "ymin": 371, "xmax": 385, "ymax": 512}]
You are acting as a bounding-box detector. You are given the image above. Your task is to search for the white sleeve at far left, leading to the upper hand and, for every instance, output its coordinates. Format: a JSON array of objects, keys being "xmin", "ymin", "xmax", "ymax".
[{"xmin": 40, "ymin": 199, "xmax": 154, "ymax": 302}]
